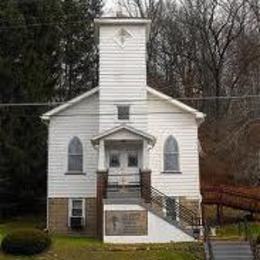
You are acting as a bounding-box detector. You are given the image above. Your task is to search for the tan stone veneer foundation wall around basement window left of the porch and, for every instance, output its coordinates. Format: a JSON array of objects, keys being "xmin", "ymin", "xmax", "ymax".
[{"xmin": 48, "ymin": 198, "xmax": 97, "ymax": 237}]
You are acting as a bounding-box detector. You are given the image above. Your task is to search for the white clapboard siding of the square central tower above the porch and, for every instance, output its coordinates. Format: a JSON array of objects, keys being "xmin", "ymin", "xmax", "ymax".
[{"xmin": 99, "ymin": 24, "xmax": 147, "ymax": 132}]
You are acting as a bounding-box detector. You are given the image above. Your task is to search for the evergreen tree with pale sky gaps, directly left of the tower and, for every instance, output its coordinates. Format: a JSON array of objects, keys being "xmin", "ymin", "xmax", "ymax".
[{"xmin": 60, "ymin": 0, "xmax": 102, "ymax": 98}]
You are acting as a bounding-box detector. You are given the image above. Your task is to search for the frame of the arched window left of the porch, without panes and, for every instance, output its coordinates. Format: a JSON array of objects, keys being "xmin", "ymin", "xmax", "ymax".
[{"xmin": 66, "ymin": 136, "xmax": 85, "ymax": 175}]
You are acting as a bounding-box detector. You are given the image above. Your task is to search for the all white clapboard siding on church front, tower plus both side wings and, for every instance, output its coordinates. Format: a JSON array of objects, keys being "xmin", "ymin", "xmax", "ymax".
[{"xmin": 48, "ymin": 18, "xmax": 200, "ymax": 203}]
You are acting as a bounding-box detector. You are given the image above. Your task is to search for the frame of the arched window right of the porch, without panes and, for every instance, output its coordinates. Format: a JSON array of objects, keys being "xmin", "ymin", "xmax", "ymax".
[{"xmin": 162, "ymin": 135, "xmax": 182, "ymax": 174}]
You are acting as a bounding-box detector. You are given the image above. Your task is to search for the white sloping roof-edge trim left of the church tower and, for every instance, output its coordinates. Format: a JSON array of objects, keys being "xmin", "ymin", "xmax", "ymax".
[{"xmin": 41, "ymin": 87, "xmax": 99, "ymax": 120}]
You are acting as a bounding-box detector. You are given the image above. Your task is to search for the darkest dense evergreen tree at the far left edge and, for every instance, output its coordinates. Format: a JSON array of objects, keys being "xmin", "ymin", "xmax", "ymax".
[{"xmin": 0, "ymin": 0, "xmax": 61, "ymax": 213}]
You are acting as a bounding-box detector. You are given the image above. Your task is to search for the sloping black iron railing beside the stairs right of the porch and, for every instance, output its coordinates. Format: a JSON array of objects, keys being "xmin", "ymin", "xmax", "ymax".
[{"xmin": 141, "ymin": 185, "xmax": 200, "ymax": 231}]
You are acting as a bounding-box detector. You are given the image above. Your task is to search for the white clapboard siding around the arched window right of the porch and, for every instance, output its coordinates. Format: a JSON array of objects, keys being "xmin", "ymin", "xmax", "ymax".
[{"xmin": 147, "ymin": 94, "xmax": 200, "ymax": 198}]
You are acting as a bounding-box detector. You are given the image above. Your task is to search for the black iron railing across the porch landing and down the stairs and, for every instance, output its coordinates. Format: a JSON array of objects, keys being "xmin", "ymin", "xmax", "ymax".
[{"xmin": 106, "ymin": 173, "xmax": 201, "ymax": 237}]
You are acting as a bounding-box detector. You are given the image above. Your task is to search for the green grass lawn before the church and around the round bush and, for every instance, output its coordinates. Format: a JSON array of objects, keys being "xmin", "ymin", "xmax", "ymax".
[{"xmin": 0, "ymin": 218, "xmax": 204, "ymax": 260}]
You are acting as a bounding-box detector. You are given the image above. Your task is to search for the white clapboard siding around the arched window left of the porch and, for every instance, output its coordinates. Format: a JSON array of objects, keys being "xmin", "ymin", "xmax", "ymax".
[{"xmin": 48, "ymin": 93, "xmax": 99, "ymax": 198}]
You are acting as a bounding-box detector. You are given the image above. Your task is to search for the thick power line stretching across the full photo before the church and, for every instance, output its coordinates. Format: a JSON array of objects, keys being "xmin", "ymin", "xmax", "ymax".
[{"xmin": 0, "ymin": 95, "xmax": 260, "ymax": 107}]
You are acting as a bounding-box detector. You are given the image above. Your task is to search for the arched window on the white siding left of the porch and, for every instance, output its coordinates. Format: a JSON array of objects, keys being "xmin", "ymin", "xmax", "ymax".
[{"xmin": 68, "ymin": 137, "xmax": 83, "ymax": 172}]
